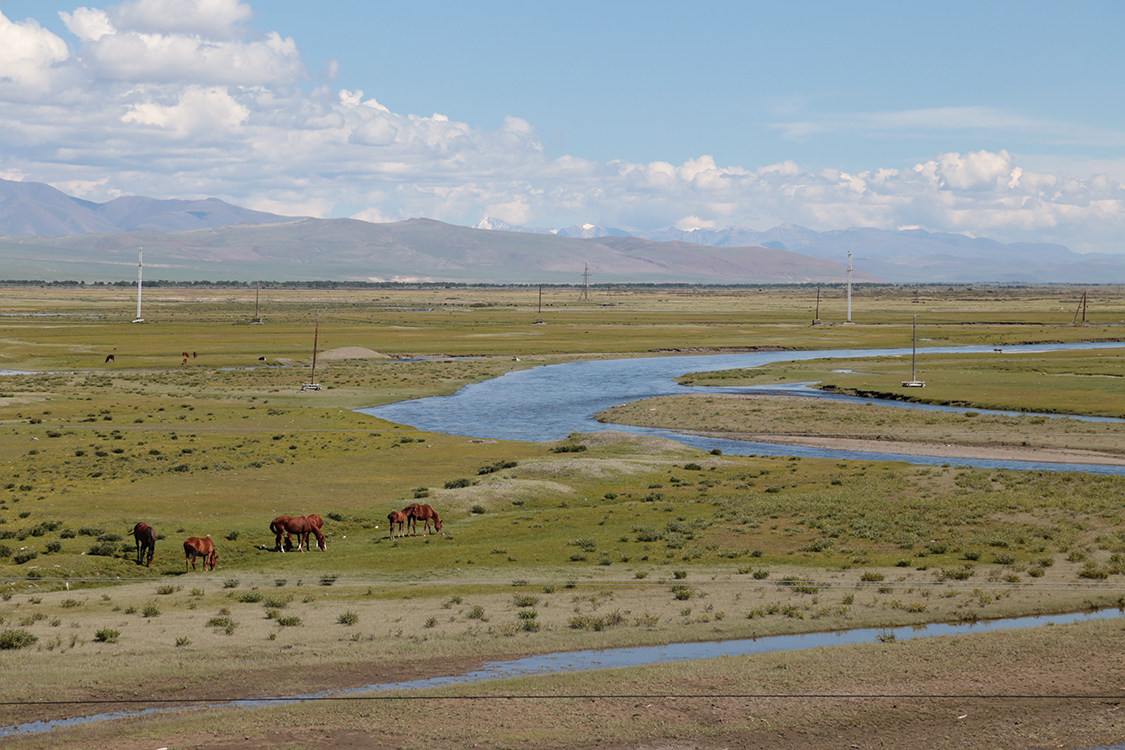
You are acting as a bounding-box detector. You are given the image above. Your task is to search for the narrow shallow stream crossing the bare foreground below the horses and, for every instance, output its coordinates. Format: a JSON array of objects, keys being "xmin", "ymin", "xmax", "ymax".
[{"xmin": 0, "ymin": 609, "xmax": 1125, "ymax": 737}]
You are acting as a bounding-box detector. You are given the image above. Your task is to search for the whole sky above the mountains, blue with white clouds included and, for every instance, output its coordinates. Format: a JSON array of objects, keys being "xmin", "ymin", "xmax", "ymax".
[{"xmin": 0, "ymin": 0, "xmax": 1125, "ymax": 252}]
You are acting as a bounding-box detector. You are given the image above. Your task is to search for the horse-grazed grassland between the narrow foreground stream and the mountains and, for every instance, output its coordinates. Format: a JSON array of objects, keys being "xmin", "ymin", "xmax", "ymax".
[{"xmin": 0, "ymin": 288, "xmax": 1125, "ymax": 742}]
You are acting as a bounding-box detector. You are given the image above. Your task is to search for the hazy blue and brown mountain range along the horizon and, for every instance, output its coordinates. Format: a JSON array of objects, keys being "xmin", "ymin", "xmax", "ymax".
[{"xmin": 0, "ymin": 180, "xmax": 1125, "ymax": 283}]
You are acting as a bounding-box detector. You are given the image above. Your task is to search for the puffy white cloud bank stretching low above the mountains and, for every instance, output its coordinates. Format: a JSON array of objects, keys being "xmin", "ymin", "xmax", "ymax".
[{"xmin": 0, "ymin": 0, "xmax": 1125, "ymax": 252}]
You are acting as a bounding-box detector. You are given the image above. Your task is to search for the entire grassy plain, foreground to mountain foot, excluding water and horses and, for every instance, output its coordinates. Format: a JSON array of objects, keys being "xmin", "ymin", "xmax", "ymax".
[{"xmin": 0, "ymin": 284, "xmax": 1125, "ymax": 750}]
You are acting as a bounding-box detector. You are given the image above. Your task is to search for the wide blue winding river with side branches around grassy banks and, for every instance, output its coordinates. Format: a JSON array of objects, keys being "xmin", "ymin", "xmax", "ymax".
[{"xmin": 359, "ymin": 342, "xmax": 1125, "ymax": 476}]
